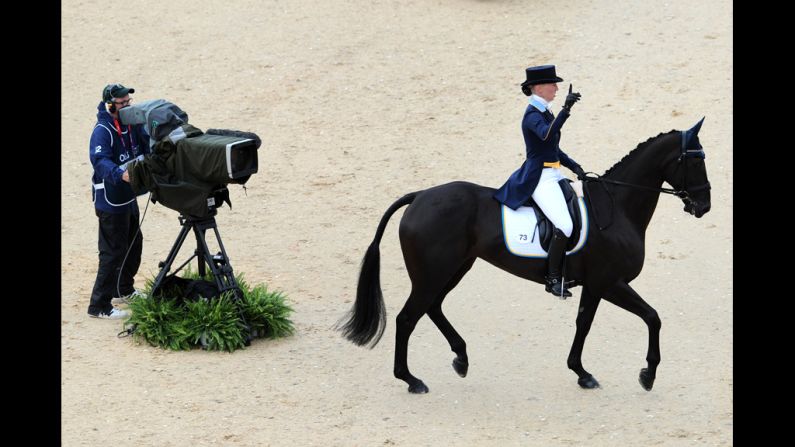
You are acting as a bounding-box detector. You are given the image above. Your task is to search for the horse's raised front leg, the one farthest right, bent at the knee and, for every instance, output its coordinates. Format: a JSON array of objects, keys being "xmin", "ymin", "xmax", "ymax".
[{"xmin": 604, "ymin": 282, "xmax": 662, "ymax": 391}]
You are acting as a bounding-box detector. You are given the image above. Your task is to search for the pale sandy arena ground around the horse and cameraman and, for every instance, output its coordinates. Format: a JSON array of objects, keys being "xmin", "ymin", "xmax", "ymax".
[{"xmin": 61, "ymin": 0, "xmax": 733, "ymax": 447}]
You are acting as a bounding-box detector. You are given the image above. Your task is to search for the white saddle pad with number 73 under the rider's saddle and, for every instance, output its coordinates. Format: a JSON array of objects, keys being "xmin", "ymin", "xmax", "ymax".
[{"xmin": 502, "ymin": 197, "xmax": 589, "ymax": 258}]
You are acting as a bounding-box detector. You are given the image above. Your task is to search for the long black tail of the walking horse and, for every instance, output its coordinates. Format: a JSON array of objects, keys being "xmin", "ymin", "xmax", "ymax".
[{"xmin": 338, "ymin": 192, "xmax": 418, "ymax": 348}]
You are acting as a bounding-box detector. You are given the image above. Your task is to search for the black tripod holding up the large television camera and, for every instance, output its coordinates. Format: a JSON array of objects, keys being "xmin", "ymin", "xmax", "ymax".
[{"xmin": 151, "ymin": 208, "xmax": 251, "ymax": 346}]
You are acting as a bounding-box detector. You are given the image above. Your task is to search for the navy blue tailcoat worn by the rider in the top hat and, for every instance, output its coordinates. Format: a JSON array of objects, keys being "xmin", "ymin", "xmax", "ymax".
[{"xmin": 494, "ymin": 104, "xmax": 580, "ymax": 210}]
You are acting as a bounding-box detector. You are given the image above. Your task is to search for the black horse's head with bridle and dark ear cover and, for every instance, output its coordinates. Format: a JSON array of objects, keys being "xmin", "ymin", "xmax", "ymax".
[{"xmin": 664, "ymin": 118, "xmax": 710, "ymax": 217}]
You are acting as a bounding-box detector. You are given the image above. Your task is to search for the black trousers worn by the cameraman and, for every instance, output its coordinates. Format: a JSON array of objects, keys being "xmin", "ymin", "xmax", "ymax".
[{"xmin": 88, "ymin": 210, "xmax": 143, "ymax": 315}]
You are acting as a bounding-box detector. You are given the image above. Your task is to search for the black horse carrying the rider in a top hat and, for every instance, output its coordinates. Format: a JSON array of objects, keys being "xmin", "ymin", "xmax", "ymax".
[{"xmin": 339, "ymin": 118, "xmax": 710, "ymax": 393}]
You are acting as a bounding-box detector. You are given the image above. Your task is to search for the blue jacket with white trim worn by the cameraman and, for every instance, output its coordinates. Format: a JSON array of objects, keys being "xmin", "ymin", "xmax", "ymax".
[{"xmin": 88, "ymin": 102, "xmax": 150, "ymax": 214}]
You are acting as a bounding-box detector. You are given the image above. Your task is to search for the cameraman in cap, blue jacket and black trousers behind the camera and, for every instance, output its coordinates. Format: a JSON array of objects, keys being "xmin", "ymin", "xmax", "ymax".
[{"xmin": 88, "ymin": 84, "xmax": 150, "ymax": 319}]
